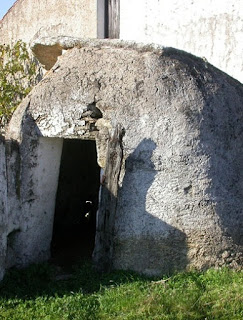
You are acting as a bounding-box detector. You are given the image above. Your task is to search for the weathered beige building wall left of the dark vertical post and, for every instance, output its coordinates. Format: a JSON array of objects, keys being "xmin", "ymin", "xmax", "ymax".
[{"xmin": 0, "ymin": 0, "xmax": 98, "ymax": 44}]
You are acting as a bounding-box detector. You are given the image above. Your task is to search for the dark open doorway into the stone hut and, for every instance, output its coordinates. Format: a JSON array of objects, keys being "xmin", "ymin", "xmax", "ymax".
[{"xmin": 51, "ymin": 139, "xmax": 100, "ymax": 267}]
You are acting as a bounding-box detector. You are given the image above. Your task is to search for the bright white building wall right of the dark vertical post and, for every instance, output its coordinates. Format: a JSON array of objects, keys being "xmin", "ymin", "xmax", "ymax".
[{"xmin": 120, "ymin": 0, "xmax": 243, "ymax": 82}]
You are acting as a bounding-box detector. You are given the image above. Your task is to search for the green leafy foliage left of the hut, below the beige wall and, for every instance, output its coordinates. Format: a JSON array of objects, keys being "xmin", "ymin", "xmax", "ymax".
[{"xmin": 0, "ymin": 41, "xmax": 38, "ymax": 129}]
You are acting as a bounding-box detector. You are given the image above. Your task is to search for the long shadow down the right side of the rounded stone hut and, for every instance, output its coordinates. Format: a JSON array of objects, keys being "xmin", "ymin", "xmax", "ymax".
[{"xmin": 163, "ymin": 48, "xmax": 243, "ymax": 251}]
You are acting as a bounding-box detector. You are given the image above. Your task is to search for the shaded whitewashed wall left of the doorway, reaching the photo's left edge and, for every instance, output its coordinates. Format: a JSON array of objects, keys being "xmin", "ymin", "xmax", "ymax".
[{"xmin": 0, "ymin": 137, "xmax": 63, "ymax": 272}]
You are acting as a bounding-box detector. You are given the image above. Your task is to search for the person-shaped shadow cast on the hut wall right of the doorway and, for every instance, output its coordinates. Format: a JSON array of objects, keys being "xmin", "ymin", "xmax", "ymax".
[{"xmin": 96, "ymin": 139, "xmax": 187, "ymax": 275}]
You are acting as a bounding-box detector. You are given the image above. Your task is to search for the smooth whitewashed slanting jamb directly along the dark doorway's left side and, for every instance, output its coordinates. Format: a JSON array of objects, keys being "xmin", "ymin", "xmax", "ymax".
[{"xmin": 12, "ymin": 138, "xmax": 63, "ymax": 266}]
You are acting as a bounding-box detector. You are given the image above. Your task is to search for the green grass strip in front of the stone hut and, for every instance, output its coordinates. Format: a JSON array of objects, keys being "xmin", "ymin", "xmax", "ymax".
[{"xmin": 0, "ymin": 263, "xmax": 243, "ymax": 320}]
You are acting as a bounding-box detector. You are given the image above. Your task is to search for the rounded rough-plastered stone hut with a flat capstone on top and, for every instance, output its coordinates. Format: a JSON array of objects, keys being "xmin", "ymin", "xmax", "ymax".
[{"xmin": 0, "ymin": 39, "xmax": 243, "ymax": 275}]
